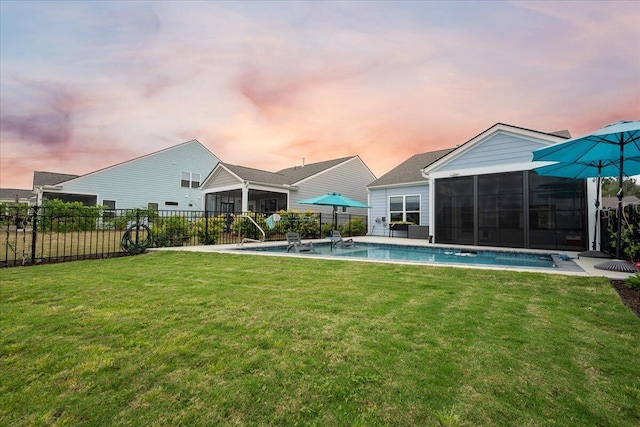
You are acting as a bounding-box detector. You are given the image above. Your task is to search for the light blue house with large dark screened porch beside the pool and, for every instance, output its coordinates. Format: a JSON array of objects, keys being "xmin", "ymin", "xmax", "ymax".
[{"xmin": 368, "ymin": 123, "xmax": 595, "ymax": 250}]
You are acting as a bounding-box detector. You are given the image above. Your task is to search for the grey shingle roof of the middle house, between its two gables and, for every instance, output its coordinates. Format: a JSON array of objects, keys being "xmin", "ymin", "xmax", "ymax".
[{"xmin": 222, "ymin": 156, "xmax": 356, "ymax": 185}]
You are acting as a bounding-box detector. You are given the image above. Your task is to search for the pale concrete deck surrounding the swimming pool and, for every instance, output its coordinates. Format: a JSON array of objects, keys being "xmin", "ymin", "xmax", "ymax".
[{"xmin": 149, "ymin": 236, "xmax": 632, "ymax": 279}]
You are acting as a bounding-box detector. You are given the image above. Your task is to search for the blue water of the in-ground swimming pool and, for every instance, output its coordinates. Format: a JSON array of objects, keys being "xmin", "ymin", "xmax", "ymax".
[{"xmin": 245, "ymin": 243, "xmax": 557, "ymax": 268}]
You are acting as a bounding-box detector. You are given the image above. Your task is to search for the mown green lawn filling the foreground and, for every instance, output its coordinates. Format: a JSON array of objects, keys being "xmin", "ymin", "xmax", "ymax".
[{"xmin": 0, "ymin": 252, "xmax": 640, "ymax": 426}]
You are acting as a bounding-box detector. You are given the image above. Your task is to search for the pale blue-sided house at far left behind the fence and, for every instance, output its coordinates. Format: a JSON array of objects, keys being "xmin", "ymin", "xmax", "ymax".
[{"xmin": 33, "ymin": 140, "xmax": 219, "ymax": 211}]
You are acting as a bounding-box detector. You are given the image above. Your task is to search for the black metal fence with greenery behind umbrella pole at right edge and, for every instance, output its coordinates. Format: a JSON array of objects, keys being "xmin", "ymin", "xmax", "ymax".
[{"xmin": 600, "ymin": 203, "xmax": 640, "ymax": 265}]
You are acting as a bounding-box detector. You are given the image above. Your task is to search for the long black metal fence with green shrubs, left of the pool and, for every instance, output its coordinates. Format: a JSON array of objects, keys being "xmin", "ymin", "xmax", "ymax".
[{"xmin": 0, "ymin": 200, "xmax": 367, "ymax": 267}]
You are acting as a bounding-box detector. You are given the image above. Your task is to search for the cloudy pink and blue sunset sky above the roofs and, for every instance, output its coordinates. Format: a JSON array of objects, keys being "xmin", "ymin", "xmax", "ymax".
[{"xmin": 0, "ymin": 0, "xmax": 640, "ymax": 188}]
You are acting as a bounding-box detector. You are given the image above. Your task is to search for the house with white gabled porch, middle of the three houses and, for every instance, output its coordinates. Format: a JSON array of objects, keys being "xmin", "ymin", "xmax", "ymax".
[{"xmin": 202, "ymin": 156, "xmax": 375, "ymax": 218}]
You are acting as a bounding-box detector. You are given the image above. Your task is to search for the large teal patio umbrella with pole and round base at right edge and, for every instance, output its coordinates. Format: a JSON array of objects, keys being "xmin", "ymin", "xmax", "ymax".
[{"xmin": 533, "ymin": 120, "xmax": 640, "ymax": 273}]
